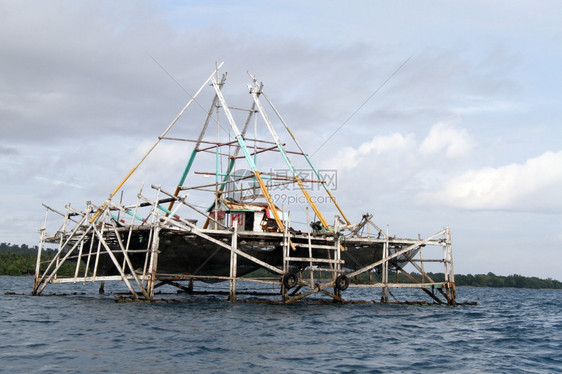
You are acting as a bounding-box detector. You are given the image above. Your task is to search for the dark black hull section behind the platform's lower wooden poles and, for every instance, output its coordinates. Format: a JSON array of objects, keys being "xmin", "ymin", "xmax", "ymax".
[{"xmin": 84, "ymin": 230, "xmax": 416, "ymax": 277}]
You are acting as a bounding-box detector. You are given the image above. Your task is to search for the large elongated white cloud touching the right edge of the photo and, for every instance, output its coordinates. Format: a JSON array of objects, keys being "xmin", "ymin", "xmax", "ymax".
[{"xmin": 420, "ymin": 151, "xmax": 562, "ymax": 211}]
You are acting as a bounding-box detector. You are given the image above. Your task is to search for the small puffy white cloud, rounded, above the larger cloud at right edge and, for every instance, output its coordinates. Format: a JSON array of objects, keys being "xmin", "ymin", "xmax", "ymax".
[{"xmin": 420, "ymin": 120, "xmax": 474, "ymax": 157}]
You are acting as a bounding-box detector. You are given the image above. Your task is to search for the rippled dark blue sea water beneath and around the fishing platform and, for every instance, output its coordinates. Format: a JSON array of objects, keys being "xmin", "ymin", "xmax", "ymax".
[{"xmin": 0, "ymin": 277, "xmax": 562, "ymax": 373}]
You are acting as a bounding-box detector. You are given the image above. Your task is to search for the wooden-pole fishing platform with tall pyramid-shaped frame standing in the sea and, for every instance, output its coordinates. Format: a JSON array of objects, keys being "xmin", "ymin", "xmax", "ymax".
[{"xmin": 32, "ymin": 64, "xmax": 456, "ymax": 305}]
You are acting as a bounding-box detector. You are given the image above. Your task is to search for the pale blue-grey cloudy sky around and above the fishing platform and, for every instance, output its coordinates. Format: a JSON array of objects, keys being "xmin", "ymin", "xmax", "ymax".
[{"xmin": 0, "ymin": 0, "xmax": 562, "ymax": 280}]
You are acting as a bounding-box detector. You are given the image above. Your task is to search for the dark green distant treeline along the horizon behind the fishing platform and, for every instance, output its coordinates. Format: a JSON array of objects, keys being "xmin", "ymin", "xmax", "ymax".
[{"xmin": 0, "ymin": 243, "xmax": 562, "ymax": 289}]
